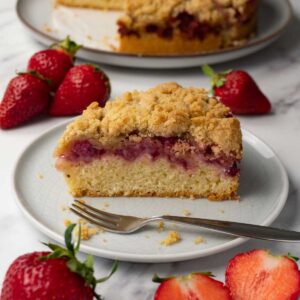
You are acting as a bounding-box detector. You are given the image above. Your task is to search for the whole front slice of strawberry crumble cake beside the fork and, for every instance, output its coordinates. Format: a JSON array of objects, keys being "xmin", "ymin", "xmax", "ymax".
[{"xmin": 55, "ymin": 83, "xmax": 242, "ymax": 200}]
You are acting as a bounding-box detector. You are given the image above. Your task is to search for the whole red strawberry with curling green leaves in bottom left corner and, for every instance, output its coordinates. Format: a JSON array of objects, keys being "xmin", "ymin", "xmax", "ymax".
[{"xmin": 1, "ymin": 224, "xmax": 117, "ymax": 300}]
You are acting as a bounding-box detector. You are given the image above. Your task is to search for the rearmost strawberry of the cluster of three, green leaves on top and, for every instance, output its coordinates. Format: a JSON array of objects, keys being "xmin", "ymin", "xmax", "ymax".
[{"xmin": 27, "ymin": 37, "xmax": 80, "ymax": 91}]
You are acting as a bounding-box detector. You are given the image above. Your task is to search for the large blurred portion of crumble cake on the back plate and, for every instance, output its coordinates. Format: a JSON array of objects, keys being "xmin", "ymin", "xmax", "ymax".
[{"xmin": 118, "ymin": 0, "xmax": 259, "ymax": 55}]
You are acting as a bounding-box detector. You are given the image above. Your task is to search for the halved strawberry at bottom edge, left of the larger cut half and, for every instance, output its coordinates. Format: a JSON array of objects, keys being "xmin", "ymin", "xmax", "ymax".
[{"xmin": 153, "ymin": 273, "xmax": 231, "ymax": 300}]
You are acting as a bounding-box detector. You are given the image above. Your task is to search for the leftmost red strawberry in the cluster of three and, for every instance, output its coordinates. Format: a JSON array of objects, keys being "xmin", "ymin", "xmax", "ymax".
[{"xmin": 0, "ymin": 72, "xmax": 50, "ymax": 129}]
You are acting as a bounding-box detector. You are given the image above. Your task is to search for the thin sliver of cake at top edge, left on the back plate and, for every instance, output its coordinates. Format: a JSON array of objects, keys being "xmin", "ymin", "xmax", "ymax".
[{"xmin": 56, "ymin": 0, "xmax": 125, "ymax": 10}]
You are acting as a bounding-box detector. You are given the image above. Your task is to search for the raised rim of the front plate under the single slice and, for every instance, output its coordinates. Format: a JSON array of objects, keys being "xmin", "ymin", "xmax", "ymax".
[{"xmin": 11, "ymin": 120, "xmax": 289, "ymax": 263}]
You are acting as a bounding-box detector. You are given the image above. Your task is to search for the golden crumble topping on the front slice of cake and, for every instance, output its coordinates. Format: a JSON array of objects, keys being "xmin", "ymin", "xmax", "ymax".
[{"xmin": 55, "ymin": 82, "xmax": 242, "ymax": 159}]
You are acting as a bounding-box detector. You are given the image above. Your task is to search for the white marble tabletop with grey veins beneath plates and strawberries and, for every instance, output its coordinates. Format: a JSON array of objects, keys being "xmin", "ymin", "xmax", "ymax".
[{"xmin": 0, "ymin": 0, "xmax": 300, "ymax": 300}]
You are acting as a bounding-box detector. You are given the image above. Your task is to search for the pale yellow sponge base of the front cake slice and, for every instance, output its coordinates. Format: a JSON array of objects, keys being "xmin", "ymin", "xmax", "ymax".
[{"xmin": 57, "ymin": 156, "xmax": 238, "ymax": 200}]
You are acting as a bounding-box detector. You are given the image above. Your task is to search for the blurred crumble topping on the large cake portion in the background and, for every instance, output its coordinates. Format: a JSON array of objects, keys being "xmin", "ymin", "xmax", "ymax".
[{"xmin": 119, "ymin": 0, "xmax": 257, "ymax": 30}]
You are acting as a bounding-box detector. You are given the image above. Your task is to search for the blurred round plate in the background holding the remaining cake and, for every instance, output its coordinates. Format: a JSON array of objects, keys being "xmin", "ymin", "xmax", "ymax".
[{"xmin": 17, "ymin": 0, "xmax": 292, "ymax": 69}]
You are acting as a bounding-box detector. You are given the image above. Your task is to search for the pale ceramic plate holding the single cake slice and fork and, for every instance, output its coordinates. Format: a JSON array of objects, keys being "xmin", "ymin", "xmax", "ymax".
[{"xmin": 13, "ymin": 124, "xmax": 288, "ymax": 262}]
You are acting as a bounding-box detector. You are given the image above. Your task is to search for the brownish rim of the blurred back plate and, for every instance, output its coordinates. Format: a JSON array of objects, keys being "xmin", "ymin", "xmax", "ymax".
[{"xmin": 15, "ymin": 0, "xmax": 293, "ymax": 59}]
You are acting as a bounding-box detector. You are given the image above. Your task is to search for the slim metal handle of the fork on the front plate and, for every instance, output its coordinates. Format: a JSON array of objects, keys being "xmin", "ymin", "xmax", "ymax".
[{"xmin": 161, "ymin": 216, "xmax": 300, "ymax": 242}]
